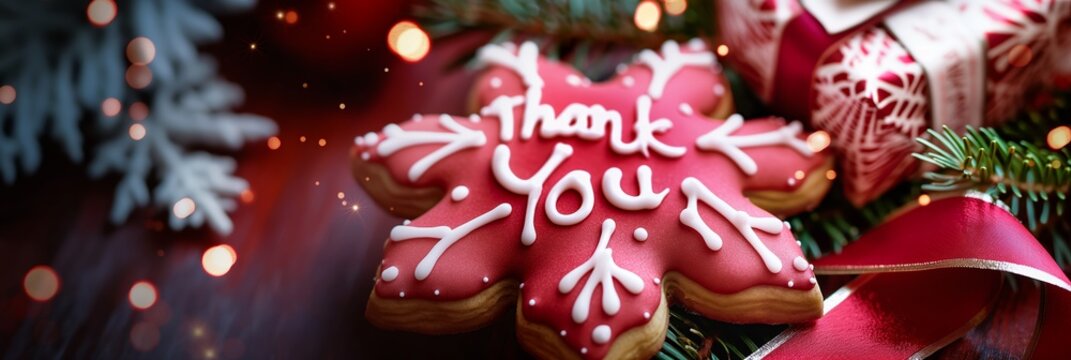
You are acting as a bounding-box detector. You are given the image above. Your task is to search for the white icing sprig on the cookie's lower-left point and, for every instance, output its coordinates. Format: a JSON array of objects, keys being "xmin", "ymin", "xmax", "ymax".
[{"xmin": 391, "ymin": 204, "xmax": 513, "ymax": 281}]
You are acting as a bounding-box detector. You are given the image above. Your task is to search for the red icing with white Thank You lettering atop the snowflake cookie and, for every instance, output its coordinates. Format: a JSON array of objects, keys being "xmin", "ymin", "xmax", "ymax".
[{"xmin": 358, "ymin": 42, "xmax": 825, "ymax": 358}]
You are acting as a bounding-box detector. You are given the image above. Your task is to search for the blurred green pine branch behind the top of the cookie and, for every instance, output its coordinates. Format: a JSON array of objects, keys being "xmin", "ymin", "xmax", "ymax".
[{"xmin": 414, "ymin": 0, "xmax": 714, "ymax": 79}]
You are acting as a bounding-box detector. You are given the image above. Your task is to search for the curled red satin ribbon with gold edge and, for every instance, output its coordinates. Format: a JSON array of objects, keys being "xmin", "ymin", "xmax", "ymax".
[{"xmin": 752, "ymin": 197, "xmax": 1071, "ymax": 359}]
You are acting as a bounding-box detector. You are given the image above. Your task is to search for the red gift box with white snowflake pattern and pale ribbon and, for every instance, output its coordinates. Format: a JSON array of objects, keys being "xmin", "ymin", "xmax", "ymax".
[{"xmin": 719, "ymin": 0, "xmax": 1071, "ymax": 204}]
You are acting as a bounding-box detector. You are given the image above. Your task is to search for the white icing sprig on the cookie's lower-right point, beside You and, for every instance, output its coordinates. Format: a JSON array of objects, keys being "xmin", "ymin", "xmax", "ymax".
[{"xmin": 680, "ymin": 177, "xmax": 785, "ymax": 273}]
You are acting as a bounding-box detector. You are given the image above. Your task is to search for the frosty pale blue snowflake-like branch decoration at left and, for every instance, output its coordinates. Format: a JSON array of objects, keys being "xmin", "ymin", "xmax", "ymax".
[{"xmin": 0, "ymin": 0, "xmax": 276, "ymax": 234}]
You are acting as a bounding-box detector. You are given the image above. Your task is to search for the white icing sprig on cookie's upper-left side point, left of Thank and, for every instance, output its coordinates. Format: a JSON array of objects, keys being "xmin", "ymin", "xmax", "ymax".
[{"xmin": 376, "ymin": 115, "xmax": 487, "ymax": 181}]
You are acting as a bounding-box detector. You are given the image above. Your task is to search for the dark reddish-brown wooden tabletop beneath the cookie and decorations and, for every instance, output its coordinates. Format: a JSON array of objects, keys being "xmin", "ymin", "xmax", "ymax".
[{"xmin": 0, "ymin": 4, "xmax": 1037, "ymax": 359}]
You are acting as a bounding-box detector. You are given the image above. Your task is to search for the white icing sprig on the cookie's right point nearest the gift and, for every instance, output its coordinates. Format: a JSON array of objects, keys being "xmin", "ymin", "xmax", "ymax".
[{"xmin": 695, "ymin": 114, "xmax": 814, "ymax": 175}]
